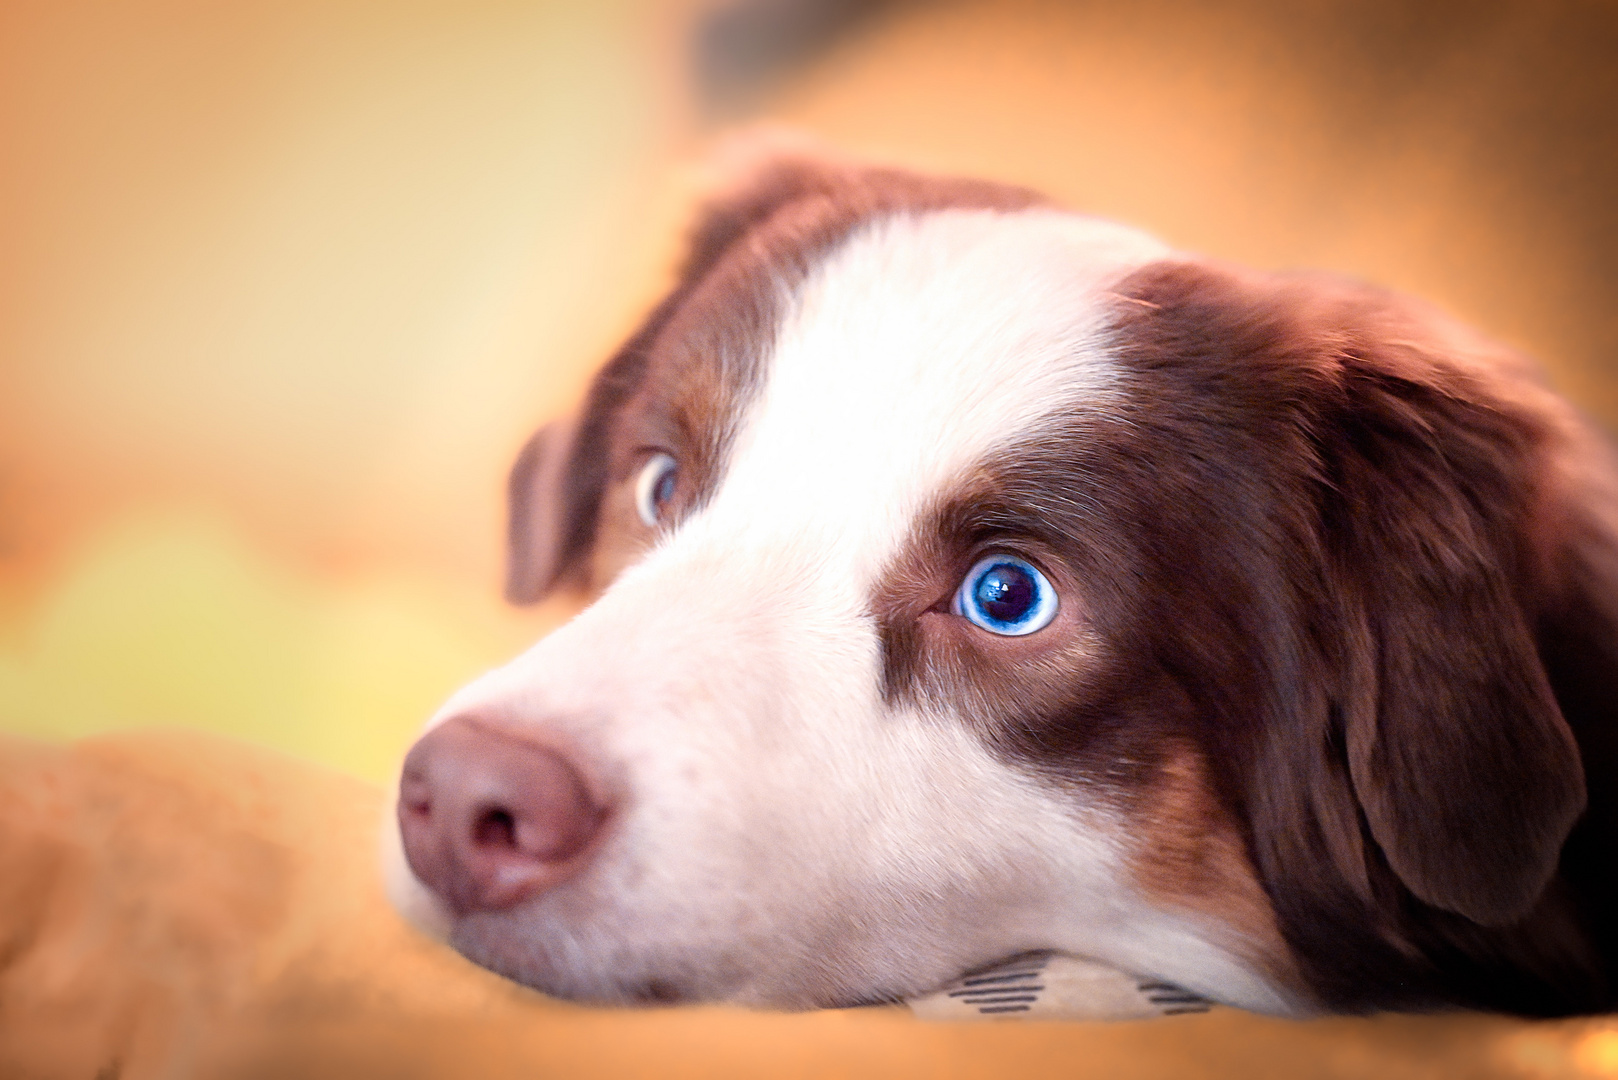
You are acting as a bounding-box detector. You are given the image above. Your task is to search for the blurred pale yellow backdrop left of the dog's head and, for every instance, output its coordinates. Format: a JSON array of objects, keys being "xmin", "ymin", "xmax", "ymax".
[{"xmin": 0, "ymin": 3, "xmax": 684, "ymax": 780}]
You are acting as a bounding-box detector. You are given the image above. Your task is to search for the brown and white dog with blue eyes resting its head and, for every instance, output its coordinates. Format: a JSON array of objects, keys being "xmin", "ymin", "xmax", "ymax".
[{"xmin": 392, "ymin": 145, "xmax": 1618, "ymax": 1015}]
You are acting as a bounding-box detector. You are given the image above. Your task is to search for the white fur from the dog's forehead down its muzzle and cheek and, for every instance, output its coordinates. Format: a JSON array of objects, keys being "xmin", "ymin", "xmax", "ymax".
[{"xmin": 395, "ymin": 210, "xmax": 1294, "ymax": 1012}]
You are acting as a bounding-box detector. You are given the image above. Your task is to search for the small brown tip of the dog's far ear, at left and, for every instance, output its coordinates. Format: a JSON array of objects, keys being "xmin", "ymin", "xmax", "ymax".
[{"xmin": 505, "ymin": 416, "xmax": 587, "ymax": 604}]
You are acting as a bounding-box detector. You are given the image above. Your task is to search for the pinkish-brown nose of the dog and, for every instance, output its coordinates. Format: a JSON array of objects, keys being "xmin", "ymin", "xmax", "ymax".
[{"xmin": 398, "ymin": 716, "xmax": 605, "ymax": 915}]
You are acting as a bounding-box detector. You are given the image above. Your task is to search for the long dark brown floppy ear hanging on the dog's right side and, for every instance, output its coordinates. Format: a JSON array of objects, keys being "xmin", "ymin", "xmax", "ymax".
[{"xmin": 1320, "ymin": 332, "xmax": 1586, "ymax": 926}]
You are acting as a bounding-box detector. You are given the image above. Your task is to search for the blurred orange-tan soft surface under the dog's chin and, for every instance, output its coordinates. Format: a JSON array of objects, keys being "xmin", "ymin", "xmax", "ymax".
[{"xmin": 0, "ymin": 732, "xmax": 1618, "ymax": 1080}]
